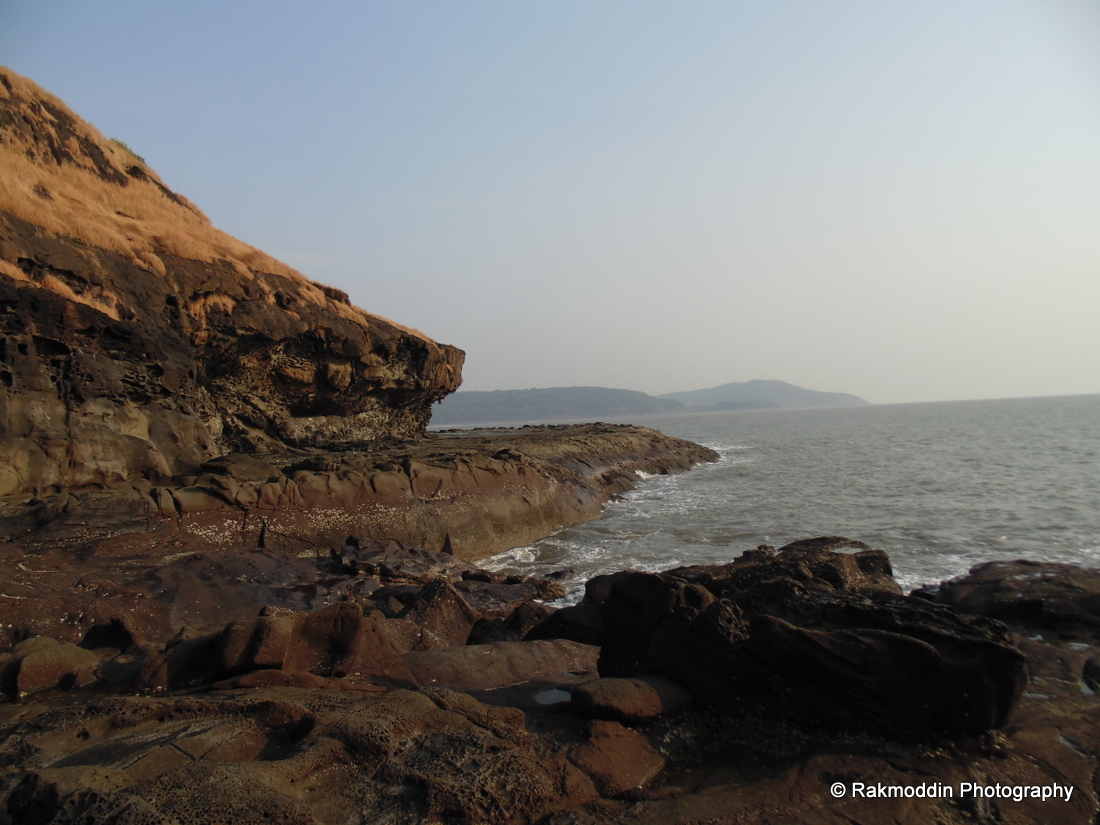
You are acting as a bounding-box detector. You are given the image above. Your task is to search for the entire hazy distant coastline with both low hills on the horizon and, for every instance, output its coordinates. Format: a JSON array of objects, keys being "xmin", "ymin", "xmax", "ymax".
[{"xmin": 431, "ymin": 380, "xmax": 869, "ymax": 426}]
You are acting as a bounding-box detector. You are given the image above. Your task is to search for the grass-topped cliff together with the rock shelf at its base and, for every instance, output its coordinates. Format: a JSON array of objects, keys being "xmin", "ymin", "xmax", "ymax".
[{"xmin": 0, "ymin": 69, "xmax": 715, "ymax": 635}]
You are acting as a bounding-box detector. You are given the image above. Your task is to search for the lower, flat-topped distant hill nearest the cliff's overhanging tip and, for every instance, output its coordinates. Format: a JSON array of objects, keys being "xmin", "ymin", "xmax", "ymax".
[{"xmin": 431, "ymin": 387, "xmax": 686, "ymax": 424}]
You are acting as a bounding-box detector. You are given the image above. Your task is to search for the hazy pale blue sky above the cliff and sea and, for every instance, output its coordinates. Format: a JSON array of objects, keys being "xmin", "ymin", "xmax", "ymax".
[{"xmin": 0, "ymin": 0, "xmax": 1100, "ymax": 403}]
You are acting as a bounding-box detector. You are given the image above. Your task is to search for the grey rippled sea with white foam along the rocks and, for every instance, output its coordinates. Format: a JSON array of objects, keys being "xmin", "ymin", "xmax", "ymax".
[{"xmin": 485, "ymin": 395, "xmax": 1100, "ymax": 602}]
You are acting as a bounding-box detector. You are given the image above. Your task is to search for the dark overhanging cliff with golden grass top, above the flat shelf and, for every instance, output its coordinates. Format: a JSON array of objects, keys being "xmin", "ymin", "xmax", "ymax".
[{"xmin": 0, "ymin": 68, "xmax": 463, "ymax": 495}]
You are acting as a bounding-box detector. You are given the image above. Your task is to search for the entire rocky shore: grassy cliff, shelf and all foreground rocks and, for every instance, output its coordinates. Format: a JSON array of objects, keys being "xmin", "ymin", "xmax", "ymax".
[{"xmin": 0, "ymin": 68, "xmax": 1100, "ymax": 825}]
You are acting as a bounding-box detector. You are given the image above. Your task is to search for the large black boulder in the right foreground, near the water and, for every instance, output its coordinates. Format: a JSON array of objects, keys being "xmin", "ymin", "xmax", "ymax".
[{"xmin": 541, "ymin": 538, "xmax": 1025, "ymax": 739}]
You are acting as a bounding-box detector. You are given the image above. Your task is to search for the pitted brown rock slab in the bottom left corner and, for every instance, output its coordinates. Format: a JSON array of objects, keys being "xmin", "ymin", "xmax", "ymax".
[{"xmin": 0, "ymin": 689, "xmax": 597, "ymax": 825}]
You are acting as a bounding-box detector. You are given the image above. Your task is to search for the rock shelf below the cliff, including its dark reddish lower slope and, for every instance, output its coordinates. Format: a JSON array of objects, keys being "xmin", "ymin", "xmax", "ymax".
[{"xmin": 0, "ymin": 425, "xmax": 715, "ymax": 641}]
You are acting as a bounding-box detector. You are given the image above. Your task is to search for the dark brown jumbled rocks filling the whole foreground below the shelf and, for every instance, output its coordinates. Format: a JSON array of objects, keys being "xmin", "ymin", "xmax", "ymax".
[{"xmin": 0, "ymin": 537, "xmax": 1100, "ymax": 825}]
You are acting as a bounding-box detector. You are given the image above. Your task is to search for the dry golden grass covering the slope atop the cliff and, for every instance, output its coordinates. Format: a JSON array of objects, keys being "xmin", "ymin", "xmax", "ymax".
[{"xmin": 0, "ymin": 67, "xmax": 430, "ymax": 340}]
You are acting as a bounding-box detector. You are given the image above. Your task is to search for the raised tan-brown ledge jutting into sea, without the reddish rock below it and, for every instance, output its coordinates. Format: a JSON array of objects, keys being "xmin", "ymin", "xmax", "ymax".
[{"xmin": 0, "ymin": 424, "xmax": 715, "ymax": 564}]
